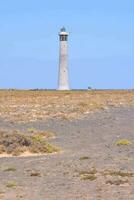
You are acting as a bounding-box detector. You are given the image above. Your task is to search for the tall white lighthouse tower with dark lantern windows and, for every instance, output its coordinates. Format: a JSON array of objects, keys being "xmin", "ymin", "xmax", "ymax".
[{"xmin": 58, "ymin": 27, "xmax": 70, "ymax": 90}]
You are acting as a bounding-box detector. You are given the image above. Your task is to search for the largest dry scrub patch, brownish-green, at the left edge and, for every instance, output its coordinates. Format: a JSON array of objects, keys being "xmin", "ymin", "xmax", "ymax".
[{"xmin": 0, "ymin": 131, "xmax": 60, "ymax": 156}]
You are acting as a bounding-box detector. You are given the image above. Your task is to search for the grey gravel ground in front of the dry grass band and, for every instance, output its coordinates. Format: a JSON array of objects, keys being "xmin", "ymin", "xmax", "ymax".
[{"xmin": 0, "ymin": 107, "xmax": 134, "ymax": 200}]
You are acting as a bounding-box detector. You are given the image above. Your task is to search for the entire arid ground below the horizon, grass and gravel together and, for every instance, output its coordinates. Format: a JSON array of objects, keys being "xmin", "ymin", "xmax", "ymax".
[{"xmin": 0, "ymin": 90, "xmax": 134, "ymax": 200}]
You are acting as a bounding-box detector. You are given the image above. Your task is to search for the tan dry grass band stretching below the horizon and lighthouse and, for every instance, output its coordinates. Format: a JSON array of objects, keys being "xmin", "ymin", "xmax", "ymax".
[{"xmin": 0, "ymin": 90, "xmax": 134, "ymax": 122}]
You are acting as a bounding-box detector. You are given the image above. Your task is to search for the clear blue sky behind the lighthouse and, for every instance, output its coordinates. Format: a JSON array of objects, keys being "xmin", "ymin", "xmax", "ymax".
[{"xmin": 0, "ymin": 0, "xmax": 134, "ymax": 89}]
